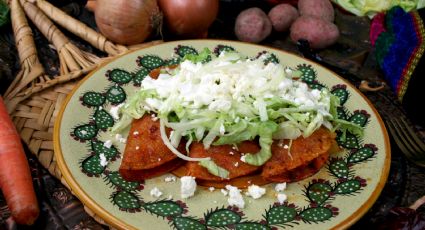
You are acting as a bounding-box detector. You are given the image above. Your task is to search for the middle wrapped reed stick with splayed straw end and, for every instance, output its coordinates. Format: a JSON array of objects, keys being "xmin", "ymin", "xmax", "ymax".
[{"xmin": 20, "ymin": 0, "xmax": 101, "ymax": 75}]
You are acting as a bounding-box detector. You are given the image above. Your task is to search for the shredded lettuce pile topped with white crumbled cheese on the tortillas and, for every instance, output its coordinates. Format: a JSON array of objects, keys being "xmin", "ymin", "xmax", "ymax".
[{"xmin": 111, "ymin": 49, "xmax": 363, "ymax": 177}]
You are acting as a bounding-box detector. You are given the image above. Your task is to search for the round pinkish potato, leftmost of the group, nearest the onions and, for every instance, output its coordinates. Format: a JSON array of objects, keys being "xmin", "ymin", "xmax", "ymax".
[{"xmin": 235, "ymin": 7, "xmax": 272, "ymax": 43}]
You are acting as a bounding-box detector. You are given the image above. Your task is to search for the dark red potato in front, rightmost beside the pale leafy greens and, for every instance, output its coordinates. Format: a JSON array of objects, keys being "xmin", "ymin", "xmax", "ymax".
[{"xmin": 290, "ymin": 16, "xmax": 339, "ymax": 49}]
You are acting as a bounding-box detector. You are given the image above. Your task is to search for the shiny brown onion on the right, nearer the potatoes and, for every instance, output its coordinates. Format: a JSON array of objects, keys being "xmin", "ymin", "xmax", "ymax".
[{"xmin": 158, "ymin": 0, "xmax": 219, "ymax": 38}]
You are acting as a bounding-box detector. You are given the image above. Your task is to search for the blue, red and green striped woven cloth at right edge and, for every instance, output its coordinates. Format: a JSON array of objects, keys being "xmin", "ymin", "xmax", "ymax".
[{"xmin": 370, "ymin": 7, "xmax": 425, "ymax": 101}]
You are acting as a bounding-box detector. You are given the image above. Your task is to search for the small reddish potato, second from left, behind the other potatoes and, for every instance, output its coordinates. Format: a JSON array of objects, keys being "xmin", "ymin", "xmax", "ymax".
[{"xmin": 268, "ymin": 4, "xmax": 299, "ymax": 32}]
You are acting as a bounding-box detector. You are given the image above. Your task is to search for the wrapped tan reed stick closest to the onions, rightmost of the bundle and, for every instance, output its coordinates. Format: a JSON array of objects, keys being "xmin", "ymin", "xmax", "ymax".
[{"xmin": 36, "ymin": 0, "xmax": 127, "ymax": 56}]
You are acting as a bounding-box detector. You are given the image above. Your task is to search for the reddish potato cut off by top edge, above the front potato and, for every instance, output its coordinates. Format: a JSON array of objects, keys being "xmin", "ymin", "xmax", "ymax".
[{"xmin": 298, "ymin": 0, "xmax": 335, "ymax": 22}]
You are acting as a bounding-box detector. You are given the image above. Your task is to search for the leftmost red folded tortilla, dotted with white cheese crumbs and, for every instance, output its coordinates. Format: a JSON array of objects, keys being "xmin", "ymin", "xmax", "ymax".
[{"xmin": 119, "ymin": 114, "xmax": 184, "ymax": 181}]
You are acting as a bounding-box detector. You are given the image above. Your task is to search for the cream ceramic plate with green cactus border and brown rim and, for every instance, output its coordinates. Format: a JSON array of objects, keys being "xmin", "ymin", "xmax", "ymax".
[{"xmin": 54, "ymin": 40, "xmax": 390, "ymax": 229}]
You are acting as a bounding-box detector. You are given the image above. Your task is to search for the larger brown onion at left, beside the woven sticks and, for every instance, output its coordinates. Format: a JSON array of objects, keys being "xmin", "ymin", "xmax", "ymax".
[{"xmin": 95, "ymin": 0, "xmax": 162, "ymax": 45}]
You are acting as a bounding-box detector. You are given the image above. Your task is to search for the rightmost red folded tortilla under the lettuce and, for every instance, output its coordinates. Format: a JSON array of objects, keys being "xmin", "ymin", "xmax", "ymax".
[{"xmin": 261, "ymin": 128, "xmax": 335, "ymax": 182}]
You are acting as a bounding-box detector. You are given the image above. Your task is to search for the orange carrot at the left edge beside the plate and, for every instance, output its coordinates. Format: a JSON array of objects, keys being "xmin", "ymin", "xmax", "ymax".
[{"xmin": 0, "ymin": 96, "xmax": 40, "ymax": 225}]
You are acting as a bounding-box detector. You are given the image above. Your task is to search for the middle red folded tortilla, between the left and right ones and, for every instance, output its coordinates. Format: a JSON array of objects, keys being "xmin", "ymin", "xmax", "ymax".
[{"xmin": 186, "ymin": 141, "xmax": 260, "ymax": 181}]
